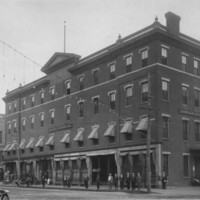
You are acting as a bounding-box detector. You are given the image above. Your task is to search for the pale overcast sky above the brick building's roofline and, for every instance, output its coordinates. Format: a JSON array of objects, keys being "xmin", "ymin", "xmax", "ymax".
[{"xmin": 0, "ymin": 0, "xmax": 200, "ymax": 113}]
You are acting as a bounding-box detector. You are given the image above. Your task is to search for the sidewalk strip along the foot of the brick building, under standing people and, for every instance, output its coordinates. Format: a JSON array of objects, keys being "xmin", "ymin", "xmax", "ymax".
[{"xmin": 0, "ymin": 183, "xmax": 200, "ymax": 199}]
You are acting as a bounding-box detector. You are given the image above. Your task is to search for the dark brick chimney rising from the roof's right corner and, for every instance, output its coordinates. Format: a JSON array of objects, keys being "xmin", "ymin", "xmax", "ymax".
[{"xmin": 165, "ymin": 12, "xmax": 181, "ymax": 35}]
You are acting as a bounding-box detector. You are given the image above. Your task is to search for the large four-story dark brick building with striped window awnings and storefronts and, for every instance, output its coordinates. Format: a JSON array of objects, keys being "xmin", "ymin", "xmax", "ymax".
[{"xmin": 1, "ymin": 12, "xmax": 200, "ymax": 185}]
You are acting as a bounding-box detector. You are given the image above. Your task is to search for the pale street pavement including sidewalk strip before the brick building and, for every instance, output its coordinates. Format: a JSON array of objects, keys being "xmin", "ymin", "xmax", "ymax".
[{"xmin": 1, "ymin": 185, "xmax": 200, "ymax": 200}]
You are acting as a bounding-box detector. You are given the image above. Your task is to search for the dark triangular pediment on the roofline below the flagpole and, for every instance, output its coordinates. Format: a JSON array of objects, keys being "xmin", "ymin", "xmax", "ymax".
[{"xmin": 41, "ymin": 53, "xmax": 80, "ymax": 73}]
